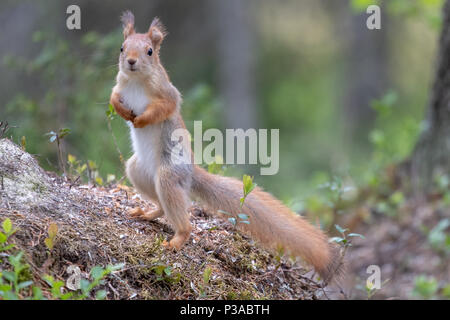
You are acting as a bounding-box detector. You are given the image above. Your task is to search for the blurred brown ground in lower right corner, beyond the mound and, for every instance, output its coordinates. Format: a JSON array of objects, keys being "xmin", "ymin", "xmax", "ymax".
[{"xmin": 343, "ymin": 184, "xmax": 450, "ymax": 299}]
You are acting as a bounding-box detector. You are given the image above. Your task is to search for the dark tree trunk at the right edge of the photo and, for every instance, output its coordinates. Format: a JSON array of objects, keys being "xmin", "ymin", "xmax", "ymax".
[{"xmin": 410, "ymin": 0, "xmax": 450, "ymax": 191}]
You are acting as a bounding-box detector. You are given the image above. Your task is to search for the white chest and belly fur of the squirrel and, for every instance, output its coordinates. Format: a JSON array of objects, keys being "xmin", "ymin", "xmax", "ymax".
[{"xmin": 120, "ymin": 83, "xmax": 162, "ymax": 179}]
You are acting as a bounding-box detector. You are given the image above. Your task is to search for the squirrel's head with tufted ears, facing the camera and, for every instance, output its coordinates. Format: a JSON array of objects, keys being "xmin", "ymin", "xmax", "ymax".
[{"xmin": 119, "ymin": 11, "xmax": 167, "ymax": 76}]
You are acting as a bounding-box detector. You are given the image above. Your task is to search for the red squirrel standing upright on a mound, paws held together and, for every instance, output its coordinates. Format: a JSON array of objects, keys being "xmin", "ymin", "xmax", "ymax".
[{"xmin": 110, "ymin": 11, "xmax": 341, "ymax": 281}]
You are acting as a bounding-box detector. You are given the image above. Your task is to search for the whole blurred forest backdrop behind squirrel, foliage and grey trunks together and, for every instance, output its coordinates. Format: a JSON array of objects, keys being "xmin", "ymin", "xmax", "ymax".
[{"xmin": 0, "ymin": 0, "xmax": 450, "ymax": 300}]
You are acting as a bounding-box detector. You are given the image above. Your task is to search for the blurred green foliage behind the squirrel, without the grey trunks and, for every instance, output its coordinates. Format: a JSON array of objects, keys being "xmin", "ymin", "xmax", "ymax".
[{"xmin": 0, "ymin": 0, "xmax": 442, "ymax": 208}]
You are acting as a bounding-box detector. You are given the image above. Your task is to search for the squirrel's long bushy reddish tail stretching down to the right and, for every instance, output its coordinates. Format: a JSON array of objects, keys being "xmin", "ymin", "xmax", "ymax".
[{"xmin": 192, "ymin": 166, "xmax": 341, "ymax": 282}]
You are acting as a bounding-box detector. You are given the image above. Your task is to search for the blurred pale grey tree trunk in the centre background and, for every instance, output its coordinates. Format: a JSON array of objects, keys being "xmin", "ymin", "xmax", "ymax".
[{"xmin": 212, "ymin": 0, "xmax": 257, "ymax": 129}]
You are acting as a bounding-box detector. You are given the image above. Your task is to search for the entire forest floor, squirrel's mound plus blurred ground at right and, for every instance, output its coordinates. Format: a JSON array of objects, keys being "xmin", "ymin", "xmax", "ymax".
[{"xmin": 0, "ymin": 139, "xmax": 450, "ymax": 299}]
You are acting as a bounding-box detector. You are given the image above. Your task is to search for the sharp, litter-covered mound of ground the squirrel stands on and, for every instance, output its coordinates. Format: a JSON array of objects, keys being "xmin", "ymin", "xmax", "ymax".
[{"xmin": 0, "ymin": 139, "xmax": 326, "ymax": 299}]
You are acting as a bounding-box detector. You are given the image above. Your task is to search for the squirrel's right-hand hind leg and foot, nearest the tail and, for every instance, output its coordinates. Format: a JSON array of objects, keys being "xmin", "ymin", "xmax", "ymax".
[{"xmin": 156, "ymin": 166, "xmax": 192, "ymax": 250}]
